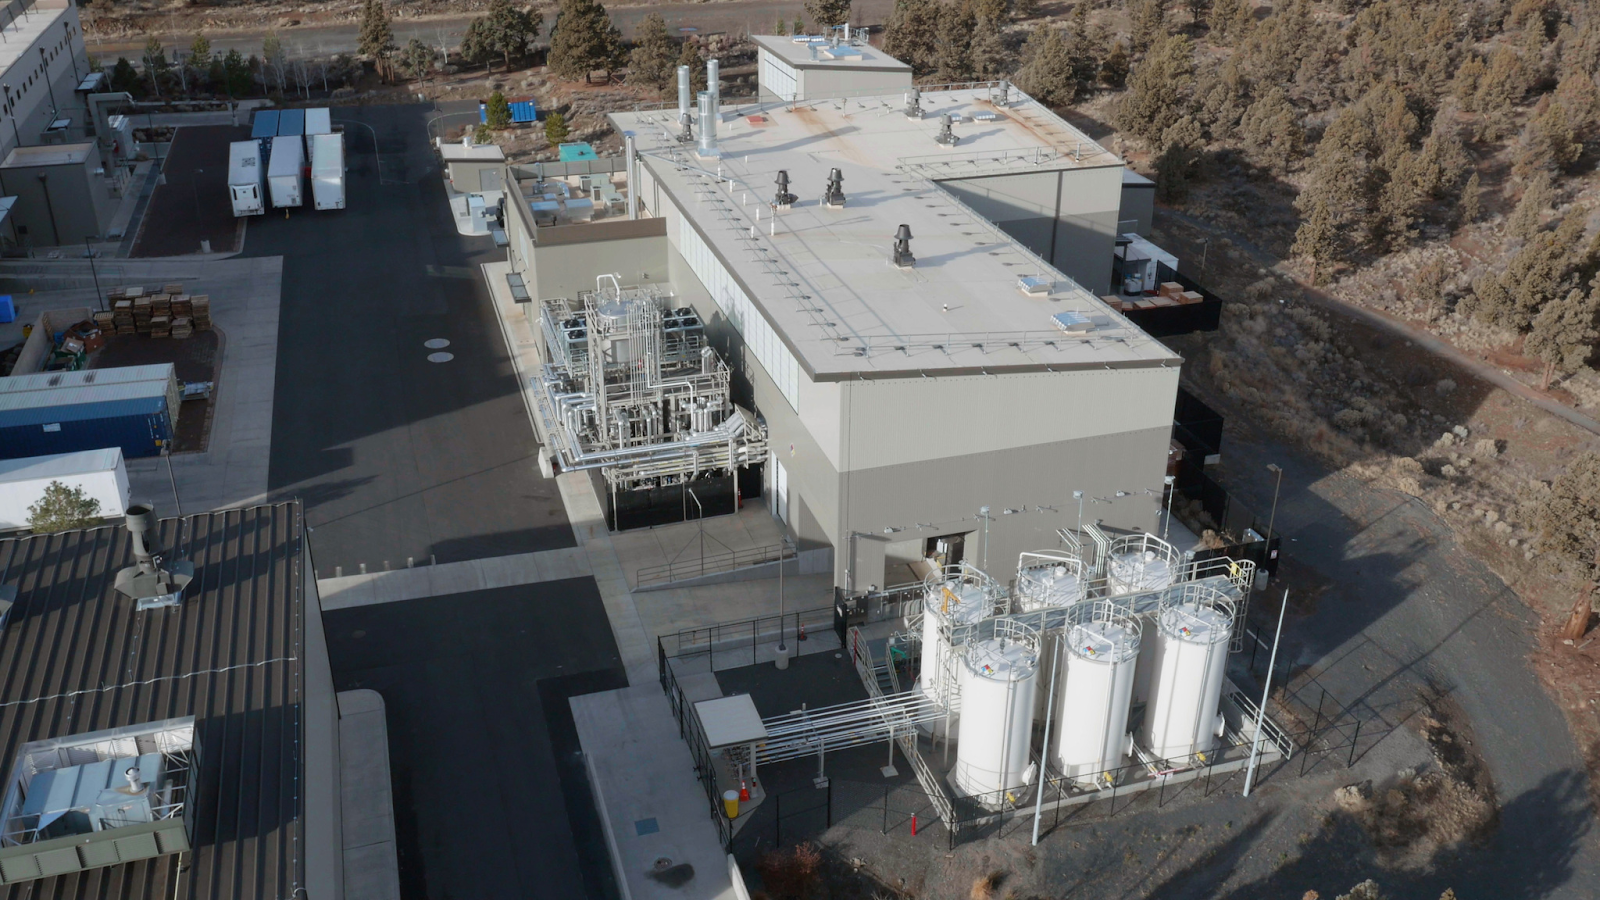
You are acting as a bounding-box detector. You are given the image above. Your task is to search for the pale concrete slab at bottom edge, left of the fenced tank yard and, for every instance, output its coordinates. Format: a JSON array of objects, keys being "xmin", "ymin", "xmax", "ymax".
[{"xmin": 570, "ymin": 682, "xmax": 738, "ymax": 900}]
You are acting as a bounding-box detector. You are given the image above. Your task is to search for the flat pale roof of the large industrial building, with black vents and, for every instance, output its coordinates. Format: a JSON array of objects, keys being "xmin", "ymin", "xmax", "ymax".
[{"xmin": 611, "ymin": 88, "xmax": 1181, "ymax": 374}]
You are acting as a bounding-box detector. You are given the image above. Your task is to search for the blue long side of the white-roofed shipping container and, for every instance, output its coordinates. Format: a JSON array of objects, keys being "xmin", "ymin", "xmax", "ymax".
[{"xmin": 0, "ymin": 397, "xmax": 173, "ymax": 460}]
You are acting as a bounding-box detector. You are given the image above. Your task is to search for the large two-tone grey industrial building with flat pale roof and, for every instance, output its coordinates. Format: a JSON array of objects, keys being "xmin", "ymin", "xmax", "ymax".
[{"xmin": 506, "ymin": 37, "xmax": 1182, "ymax": 591}]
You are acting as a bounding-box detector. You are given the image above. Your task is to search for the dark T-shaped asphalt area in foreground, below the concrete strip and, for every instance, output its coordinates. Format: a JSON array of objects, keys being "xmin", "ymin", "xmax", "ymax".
[{"xmin": 323, "ymin": 578, "xmax": 627, "ymax": 900}]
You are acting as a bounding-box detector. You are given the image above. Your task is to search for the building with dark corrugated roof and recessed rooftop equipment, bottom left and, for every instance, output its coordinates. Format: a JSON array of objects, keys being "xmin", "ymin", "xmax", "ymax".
[{"xmin": 0, "ymin": 503, "xmax": 344, "ymax": 900}]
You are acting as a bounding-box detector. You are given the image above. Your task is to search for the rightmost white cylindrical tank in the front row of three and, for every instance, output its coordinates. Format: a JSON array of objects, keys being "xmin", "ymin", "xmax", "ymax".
[{"xmin": 1139, "ymin": 589, "xmax": 1234, "ymax": 761}]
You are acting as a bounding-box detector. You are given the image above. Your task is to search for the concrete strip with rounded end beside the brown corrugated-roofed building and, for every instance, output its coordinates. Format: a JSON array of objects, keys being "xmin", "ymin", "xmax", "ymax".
[{"xmin": 338, "ymin": 690, "xmax": 400, "ymax": 900}]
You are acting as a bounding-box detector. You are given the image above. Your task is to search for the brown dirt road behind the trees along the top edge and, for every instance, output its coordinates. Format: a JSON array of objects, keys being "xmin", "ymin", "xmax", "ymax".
[{"xmin": 85, "ymin": 0, "xmax": 894, "ymax": 59}]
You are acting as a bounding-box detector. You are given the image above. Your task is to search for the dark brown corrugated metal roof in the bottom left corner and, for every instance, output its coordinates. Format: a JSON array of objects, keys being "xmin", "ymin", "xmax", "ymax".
[{"xmin": 0, "ymin": 503, "xmax": 306, "ymax": 900}]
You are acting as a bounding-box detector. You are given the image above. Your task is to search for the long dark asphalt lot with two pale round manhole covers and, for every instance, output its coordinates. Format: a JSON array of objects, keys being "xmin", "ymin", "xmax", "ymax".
[{"xmin": 245, "ymin": 104, "xmax": 574, "ymax": 566}]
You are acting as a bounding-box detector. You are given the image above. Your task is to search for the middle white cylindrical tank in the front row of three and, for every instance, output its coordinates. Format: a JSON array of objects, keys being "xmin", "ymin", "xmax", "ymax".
[{"xmin": 1054, "ymin": 617, "xmax": 1139, "ymax": 783}]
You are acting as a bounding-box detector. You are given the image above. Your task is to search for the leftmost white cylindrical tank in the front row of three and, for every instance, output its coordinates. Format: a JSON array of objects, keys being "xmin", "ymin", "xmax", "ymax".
[{"xmin": 954, "ymin": 637, "xmax": 1038, "ymax": 794}]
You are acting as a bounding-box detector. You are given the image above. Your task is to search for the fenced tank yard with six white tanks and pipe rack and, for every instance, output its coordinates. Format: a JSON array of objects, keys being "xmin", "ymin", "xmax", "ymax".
[{"xmin": 661, "ymin": 525, "xmax": 1324, "ymax": 855}]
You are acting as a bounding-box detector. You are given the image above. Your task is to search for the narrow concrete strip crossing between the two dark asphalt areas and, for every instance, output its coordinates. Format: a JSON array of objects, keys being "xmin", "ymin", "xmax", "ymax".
[{"xmin": 317, "ymin": 548, "xmax": 590, "ymax": 610}]
